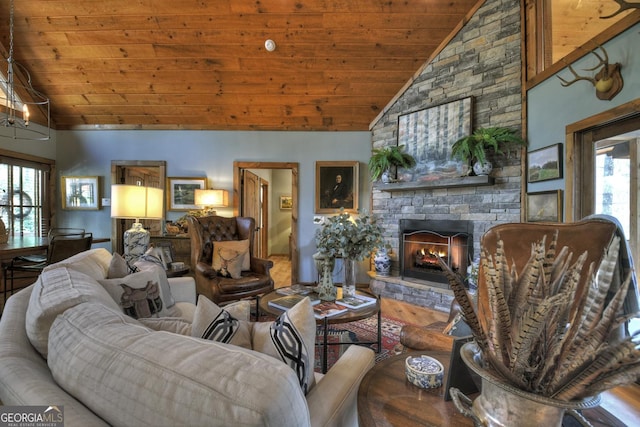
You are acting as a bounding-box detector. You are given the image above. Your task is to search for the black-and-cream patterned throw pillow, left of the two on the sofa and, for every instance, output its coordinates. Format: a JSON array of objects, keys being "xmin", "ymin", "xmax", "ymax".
[{"xmin": 191, "ymin": 295, "xmax": 251, "ymax": 349}]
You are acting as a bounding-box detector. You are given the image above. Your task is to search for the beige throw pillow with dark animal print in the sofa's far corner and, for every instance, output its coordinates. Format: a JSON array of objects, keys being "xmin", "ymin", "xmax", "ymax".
[{"xmin": 98, "ymin": 270, "xmax": 170, "ymax": 319}]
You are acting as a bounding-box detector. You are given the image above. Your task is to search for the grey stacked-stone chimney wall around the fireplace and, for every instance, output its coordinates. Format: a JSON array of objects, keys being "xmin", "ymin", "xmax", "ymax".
[{"xmin": 371, "ymin": 0, "xmax": 523, "ymax": 311}]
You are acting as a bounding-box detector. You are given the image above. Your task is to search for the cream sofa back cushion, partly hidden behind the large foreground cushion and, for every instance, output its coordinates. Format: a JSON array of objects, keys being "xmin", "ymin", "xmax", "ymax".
[{"xmin": 26, "ymin": 266, "xmax": 118, "ymax": 358}]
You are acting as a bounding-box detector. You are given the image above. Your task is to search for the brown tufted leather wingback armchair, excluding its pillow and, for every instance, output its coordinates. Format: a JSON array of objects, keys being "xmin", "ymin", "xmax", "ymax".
[{"xmin": 187, "ymin": 215, "xmax": 273, "ymax": 304}]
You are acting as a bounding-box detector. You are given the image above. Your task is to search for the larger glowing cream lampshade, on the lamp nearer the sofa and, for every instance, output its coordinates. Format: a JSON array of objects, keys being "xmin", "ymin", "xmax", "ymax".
[{"xmin": 111, "ymin": 184, "xmax": 164, "ymax": 220}]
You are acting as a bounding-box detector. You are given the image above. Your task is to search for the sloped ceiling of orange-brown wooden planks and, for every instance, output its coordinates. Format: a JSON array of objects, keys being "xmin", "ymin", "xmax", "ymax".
[{"xmin": 0, "ymin": 0, "xmax": 477, "ymax": 131}]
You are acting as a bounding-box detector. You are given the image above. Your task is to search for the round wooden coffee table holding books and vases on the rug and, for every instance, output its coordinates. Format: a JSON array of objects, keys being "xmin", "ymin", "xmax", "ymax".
[{"xmin": 258, "ymin": 288, "xmax": 382, "ymax": 373}]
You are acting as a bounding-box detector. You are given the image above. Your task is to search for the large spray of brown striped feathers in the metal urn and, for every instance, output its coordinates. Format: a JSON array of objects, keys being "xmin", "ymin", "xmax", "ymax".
[{"xmin": 440, "ymin": 232, "xmax": 640, "ymax": 401}]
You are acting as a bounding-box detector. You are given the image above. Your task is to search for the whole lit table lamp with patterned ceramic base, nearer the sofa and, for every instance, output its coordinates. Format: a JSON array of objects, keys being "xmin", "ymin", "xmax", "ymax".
[{"xmin": 111, "ymin": 184, "xmax": 163, "ymax": 264}]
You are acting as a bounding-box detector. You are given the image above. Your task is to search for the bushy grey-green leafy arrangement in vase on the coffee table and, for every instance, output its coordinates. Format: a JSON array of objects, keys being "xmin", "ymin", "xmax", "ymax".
[{"xmin": 316, "ymin": 209, "xmax": 383, "ymax": 261}]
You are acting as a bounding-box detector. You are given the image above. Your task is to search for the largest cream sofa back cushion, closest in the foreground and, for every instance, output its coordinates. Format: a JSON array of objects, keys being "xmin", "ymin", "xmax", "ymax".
[{"xmin": 48, "ymin": 303, "xmax": 310, "ymax": 427}]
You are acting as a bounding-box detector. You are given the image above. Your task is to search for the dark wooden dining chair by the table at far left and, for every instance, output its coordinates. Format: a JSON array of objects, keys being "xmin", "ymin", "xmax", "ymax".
[{"xmin": 3, "ymin": 228, "xmax": 93, "ymax": 301}]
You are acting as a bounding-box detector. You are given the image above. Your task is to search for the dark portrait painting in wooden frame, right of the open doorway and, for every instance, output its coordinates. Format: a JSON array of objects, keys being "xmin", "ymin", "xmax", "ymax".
[{"xmin": 315, "ymin": 161, "xmax": 359, "ymax": 213}]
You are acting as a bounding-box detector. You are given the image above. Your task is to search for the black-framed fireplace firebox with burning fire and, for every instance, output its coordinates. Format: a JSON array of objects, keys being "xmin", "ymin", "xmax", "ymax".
[{"xmin": 399, "ymin": 219, "xmax": 473, "ymax": 284}]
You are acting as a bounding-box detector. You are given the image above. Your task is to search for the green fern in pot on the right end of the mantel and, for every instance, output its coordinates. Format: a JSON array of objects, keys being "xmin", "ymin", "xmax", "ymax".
[{"xmin": 451, "ymin": 126, "xmax": 527, "ymax": 175}]
